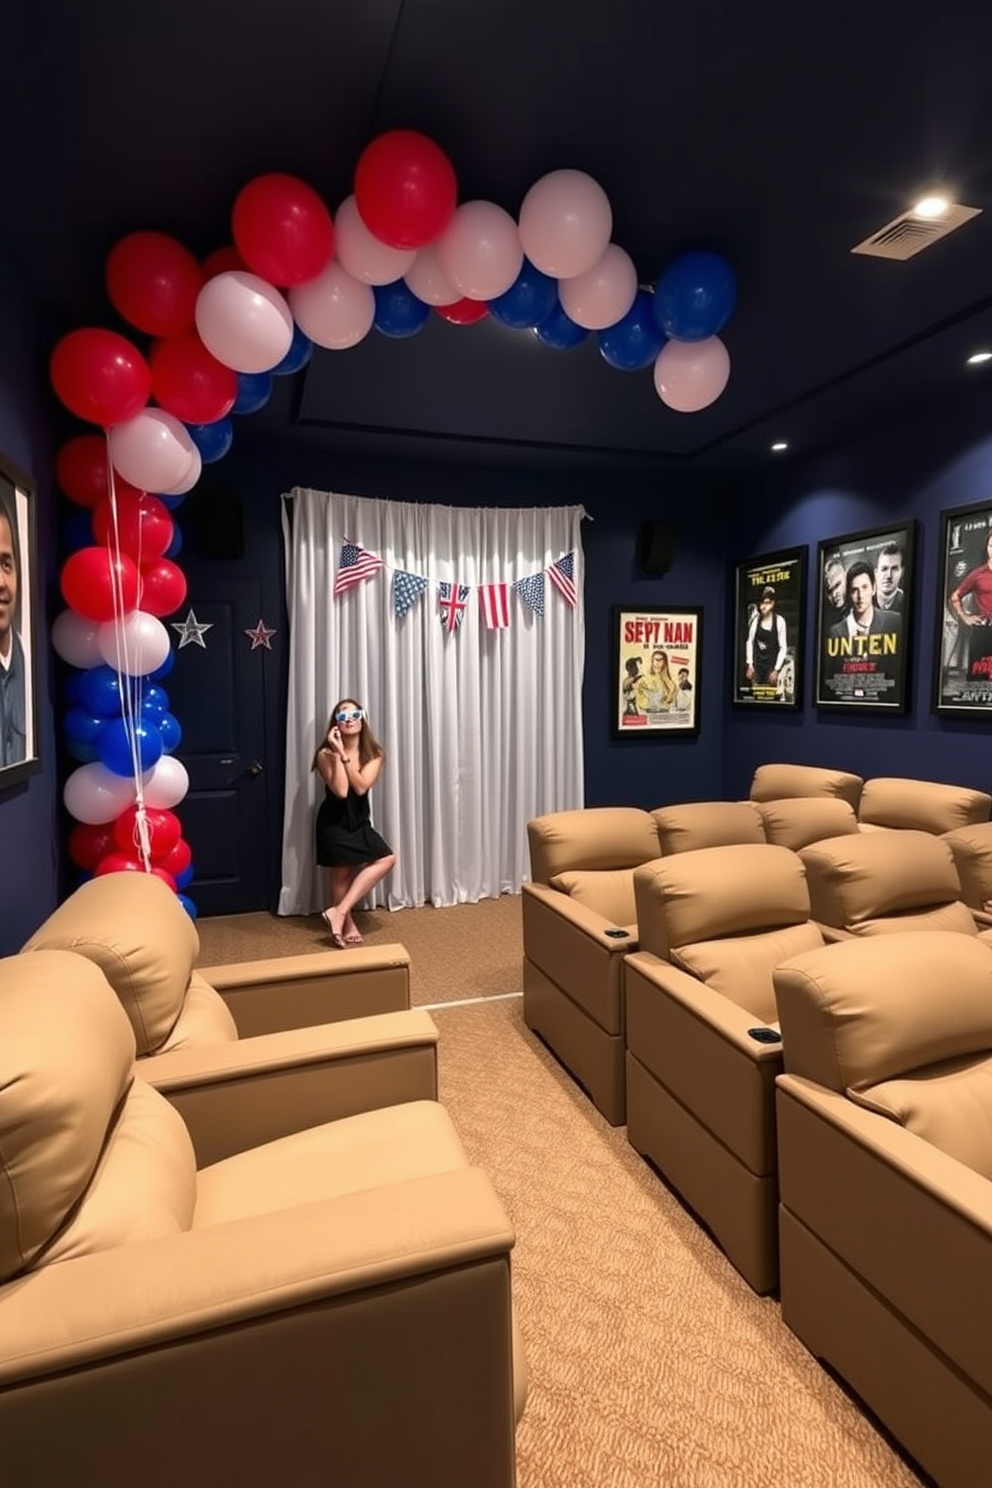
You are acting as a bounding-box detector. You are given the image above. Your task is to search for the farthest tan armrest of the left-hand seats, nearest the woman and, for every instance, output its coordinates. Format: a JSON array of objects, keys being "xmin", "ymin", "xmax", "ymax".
[{"xmin": 196, "ymin": 945, "xmax": 410, "ymax": 1039}]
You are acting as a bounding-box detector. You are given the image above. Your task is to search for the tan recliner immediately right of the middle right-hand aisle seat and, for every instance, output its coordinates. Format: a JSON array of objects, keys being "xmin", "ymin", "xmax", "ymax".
[{"xmin": 799, "ymin": 829, "xmax": 977, "ymax": 937}]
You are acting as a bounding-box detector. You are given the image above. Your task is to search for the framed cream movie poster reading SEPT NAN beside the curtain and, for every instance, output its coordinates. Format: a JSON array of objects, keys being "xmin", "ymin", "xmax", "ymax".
[{"xmin": 613, "ymin": 607, "xmax": 702, "ymax": 738}]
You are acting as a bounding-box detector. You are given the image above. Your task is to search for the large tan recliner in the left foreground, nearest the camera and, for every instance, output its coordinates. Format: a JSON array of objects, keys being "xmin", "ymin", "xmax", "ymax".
[{"xmin": 0, "ymin": 951, "xmax": 525, "ymax": 1488}]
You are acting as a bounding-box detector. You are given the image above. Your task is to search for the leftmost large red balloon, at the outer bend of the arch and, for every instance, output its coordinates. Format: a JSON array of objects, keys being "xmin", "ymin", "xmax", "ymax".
[{"xmin": 49, "ymin": 327, "xmax": 152, "ymax": 429}]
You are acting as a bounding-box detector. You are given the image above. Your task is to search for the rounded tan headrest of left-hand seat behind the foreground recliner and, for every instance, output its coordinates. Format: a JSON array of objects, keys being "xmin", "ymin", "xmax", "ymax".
[{"xmin": 24, "ymin": 872, "xmax": 199, "ymax": 1056}]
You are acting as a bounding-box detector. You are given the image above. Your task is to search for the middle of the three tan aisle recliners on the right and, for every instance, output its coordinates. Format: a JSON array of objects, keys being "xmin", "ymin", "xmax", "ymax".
[{"xmin": 625, "ymin": 844, "xmax": 822, "ymax": 1292}]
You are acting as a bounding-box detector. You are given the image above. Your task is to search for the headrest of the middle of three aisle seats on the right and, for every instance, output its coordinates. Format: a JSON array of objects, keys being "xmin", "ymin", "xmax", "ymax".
[{"xmin": 634, "ymin": 842, "xmax": 809, "ymax": 961}]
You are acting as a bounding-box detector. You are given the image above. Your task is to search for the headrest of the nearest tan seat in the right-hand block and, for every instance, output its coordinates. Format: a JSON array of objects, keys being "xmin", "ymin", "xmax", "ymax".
[{"xmin": 773, "ymin": 930, "xmax": 992, "ymax": 1092}]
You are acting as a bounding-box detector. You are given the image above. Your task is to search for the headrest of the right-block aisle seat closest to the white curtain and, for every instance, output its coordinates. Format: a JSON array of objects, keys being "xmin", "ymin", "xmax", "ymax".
[{"xmin": 526, "ymin": 806, "xmax": 662, "ymax": 884}]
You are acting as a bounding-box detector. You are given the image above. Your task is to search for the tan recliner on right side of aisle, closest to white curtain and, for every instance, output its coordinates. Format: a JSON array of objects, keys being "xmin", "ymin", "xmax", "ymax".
[{"xmin": 522, "ymin": 806, "xmax": 660, "ymax": 1126}]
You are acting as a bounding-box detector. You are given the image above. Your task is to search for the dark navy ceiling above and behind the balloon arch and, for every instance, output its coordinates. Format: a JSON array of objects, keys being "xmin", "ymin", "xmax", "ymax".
[{"xmin": 0, "ymin": 0, "xmax": 992, "ymax": 472}]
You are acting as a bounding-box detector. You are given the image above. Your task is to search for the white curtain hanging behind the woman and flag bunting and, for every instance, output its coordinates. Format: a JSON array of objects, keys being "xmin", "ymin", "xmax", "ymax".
[{"xmin": 278, "ymin": 487, "xmax": 586, "ymax": 915}]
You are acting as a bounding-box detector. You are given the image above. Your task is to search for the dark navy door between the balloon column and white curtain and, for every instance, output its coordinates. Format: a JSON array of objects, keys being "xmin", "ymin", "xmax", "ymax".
[{"xmin": 162, "ymin": 568, "xmax": 275, "ymax": 915}]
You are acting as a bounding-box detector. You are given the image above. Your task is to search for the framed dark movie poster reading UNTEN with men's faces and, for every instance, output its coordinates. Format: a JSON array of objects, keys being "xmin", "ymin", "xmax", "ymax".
[{"xmin": 817, "ymin": 522, "xmax": 916, "ymax": 713}]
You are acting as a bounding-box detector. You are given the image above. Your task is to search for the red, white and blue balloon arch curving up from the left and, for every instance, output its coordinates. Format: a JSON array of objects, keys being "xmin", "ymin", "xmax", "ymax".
[{"xmin": 51, "ymin": 129, "xmax": 736, "ymax": 917}]
